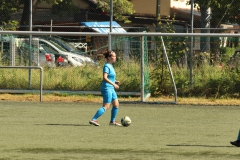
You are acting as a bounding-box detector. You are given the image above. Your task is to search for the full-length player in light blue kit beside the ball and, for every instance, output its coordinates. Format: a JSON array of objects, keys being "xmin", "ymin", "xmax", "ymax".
[{"xmin": 89, "ymin": 51, "xmax": 121, "ymax": 126}]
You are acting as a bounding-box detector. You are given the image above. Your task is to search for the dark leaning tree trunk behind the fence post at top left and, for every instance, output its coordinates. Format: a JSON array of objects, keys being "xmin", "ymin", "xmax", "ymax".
[{"xmin": 20, "ymin": 0, "xmax": 38, "ymax": 31}]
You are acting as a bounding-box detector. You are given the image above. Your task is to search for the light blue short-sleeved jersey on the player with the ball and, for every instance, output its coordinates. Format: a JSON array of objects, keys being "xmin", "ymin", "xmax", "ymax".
[{"xmin": 101, "ymin": 63, "xmax": 116, "ymax": 90}]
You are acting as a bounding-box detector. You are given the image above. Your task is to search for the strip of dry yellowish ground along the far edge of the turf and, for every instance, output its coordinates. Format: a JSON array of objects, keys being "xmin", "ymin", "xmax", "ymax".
[{"xmin": 0, "ymin": 94, "xmax": 240, "ymax": 106}]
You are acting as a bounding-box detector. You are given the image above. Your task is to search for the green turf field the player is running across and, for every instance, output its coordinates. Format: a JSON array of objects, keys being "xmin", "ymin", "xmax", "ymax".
[{"xmin": 0, "ymin": 102, "xmax": 240, "ymax": 160}]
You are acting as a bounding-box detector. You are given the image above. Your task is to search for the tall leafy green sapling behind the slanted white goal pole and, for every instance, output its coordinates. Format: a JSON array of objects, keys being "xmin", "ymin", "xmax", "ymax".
[{"xmin": 151, "ymin": 16, "xmax": 188, "ymax": 95}]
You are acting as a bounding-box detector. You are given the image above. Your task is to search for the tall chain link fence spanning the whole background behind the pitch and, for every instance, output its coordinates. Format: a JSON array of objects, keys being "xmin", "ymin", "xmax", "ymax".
[{"xmin": 0, "ymin": 0, "xmax": 240, "ymax": 98}]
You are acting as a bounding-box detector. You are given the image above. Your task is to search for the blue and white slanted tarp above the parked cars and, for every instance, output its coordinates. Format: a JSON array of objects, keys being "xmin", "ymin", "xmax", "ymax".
[{"xmin": 81, "ymin": 21, "xmax": 126, "ymax": 33}]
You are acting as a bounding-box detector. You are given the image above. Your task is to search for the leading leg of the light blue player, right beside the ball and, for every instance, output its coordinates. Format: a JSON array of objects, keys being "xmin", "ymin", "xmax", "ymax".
[{"xmin": 109, "ymin": 90, "xmax": 121, "ymax": 126}]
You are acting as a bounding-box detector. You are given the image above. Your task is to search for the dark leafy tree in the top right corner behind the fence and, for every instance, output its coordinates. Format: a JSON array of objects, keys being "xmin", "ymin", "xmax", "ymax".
[{"xmin": 188, "ymin": 0, "xmax": 240, "ymax": 61}]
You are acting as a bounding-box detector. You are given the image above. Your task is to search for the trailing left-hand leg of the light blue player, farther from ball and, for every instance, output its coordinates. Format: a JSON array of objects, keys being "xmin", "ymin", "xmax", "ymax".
[{"xmin": 89, "ymin": 91, "xmax": 112, "ymax": 126}]
